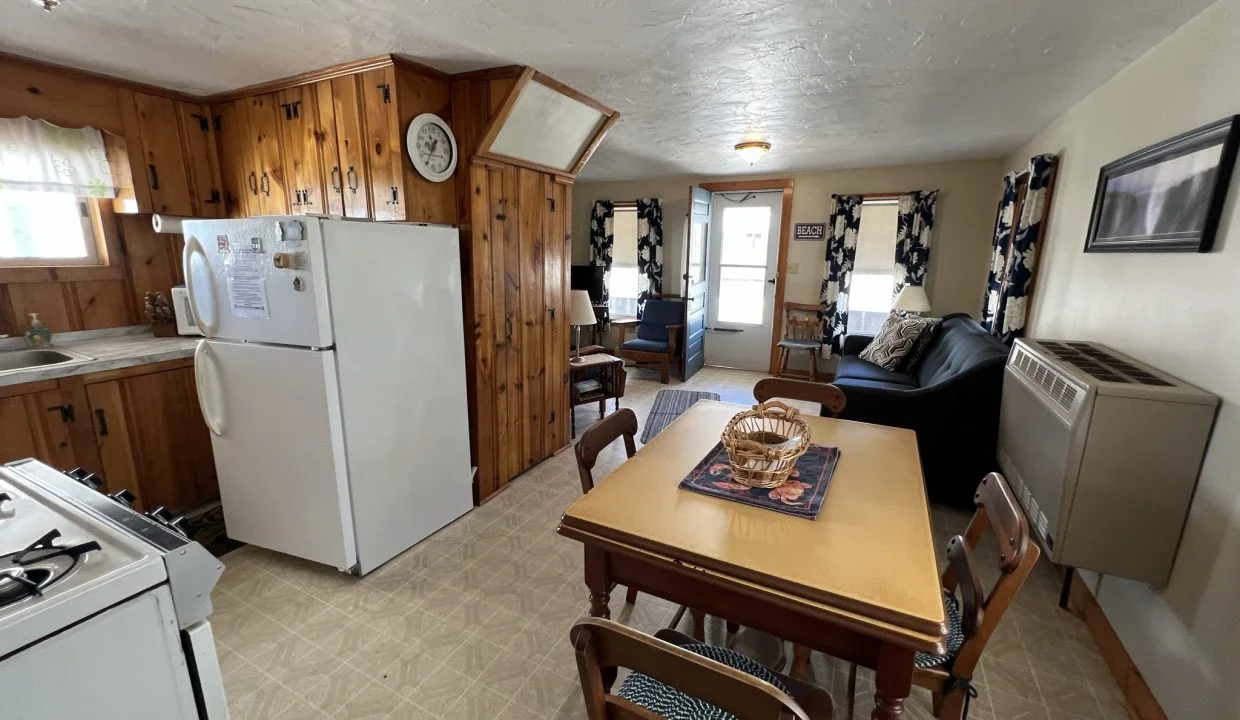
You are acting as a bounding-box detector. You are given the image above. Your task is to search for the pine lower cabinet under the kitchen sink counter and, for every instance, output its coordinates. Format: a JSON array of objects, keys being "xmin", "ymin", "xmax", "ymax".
[{"xmin": 0, "ymin": 359, "xmax": 219, "ymax": 513}]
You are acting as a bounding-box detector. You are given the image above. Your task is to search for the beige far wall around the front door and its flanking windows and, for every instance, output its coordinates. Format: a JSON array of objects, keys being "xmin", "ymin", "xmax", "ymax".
[{"xmin": 573, "ymin": 160, "xmax": 1003, "ymax": 317}]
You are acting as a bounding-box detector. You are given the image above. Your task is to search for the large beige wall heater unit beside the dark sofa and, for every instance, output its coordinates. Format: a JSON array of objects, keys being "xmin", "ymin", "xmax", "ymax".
[{"xmin": 998, "ymin": 340, "xmax": 1219, "ymax": 585}]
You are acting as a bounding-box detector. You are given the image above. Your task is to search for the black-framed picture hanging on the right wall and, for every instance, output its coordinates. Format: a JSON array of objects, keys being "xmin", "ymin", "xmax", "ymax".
[{"xmin": 1085, "ymin": 115, "xmax": 1240, "ymax": 253}]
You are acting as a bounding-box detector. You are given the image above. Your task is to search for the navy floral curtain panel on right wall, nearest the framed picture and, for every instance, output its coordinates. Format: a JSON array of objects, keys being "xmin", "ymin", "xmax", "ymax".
[{"xmin": 992, "ymin": 154, "xmax": 1058, "ymax": 345}]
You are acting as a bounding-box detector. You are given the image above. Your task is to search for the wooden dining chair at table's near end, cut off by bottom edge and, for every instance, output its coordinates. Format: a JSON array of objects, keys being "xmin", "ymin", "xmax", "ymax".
[{"xmin": 569, "ymin": 617, "xmax": 833, "ymax": 720}]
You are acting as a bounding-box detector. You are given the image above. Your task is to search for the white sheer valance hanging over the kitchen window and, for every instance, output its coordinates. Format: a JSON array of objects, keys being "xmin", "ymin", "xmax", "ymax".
[{"xmin": 0, "ymin": 118, "xmax": 119, "ymax": 198}]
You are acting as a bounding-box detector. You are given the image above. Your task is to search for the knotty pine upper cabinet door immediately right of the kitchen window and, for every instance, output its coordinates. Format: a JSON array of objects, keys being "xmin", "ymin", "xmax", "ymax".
[{"xmin": 134, "ymin": 93, "xmax": 193, "ymax": 216}]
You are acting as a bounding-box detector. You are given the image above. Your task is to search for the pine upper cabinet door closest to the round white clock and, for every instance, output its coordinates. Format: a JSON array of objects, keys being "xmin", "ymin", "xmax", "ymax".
[{"xmin": 361, "ymin": 67, "xmax": 408, "ymax": 221}]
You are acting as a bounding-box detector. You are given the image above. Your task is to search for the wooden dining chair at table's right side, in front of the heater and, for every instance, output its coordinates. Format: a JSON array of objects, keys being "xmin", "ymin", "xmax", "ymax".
[{"xmin": 828, "ymin": 472, "xmax": 1042, "ymax": 720}]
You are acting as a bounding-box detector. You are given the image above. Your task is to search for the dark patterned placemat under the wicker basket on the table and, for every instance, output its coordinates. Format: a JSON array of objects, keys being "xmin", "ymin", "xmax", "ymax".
[{"xmin": 681, "ymin": 442, "xmax": 839, "ymax": 520}]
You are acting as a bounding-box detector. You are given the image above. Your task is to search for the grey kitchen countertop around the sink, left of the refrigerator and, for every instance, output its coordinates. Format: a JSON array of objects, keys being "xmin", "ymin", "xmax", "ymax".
[{"xmin": 0, "ymin": 325, "xmax": 200, "ymax": 387}]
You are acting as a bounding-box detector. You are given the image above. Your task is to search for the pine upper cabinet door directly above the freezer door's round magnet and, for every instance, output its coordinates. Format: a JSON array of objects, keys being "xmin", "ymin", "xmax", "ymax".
[{"xmin": 275, "ymin": 86, "xmax": 327, "ymax": 214}]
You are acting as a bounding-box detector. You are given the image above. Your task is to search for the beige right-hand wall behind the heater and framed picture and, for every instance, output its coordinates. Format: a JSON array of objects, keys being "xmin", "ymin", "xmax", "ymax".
[{"xmin": 1009, "ymin": 0, "xmax": 1240, "ymax": 720}]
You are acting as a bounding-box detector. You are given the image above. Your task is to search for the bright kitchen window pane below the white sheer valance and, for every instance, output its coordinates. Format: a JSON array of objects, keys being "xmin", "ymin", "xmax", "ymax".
[{"xmin": 0, "ymin": 190, "xmax": 100, "ymax": 268}]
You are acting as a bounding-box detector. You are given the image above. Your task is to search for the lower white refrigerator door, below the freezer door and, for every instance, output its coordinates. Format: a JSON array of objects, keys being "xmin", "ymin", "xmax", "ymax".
[{"xmin": 195, "ymin": 340, "xmax": 357, "ymax": 570}]
